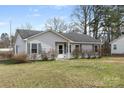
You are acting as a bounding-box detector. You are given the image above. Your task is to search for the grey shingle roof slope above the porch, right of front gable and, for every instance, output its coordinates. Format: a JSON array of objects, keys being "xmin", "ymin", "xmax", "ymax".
[{"xmin": 61, "ymin": 32, "xmax": 100, "ymax": 42}]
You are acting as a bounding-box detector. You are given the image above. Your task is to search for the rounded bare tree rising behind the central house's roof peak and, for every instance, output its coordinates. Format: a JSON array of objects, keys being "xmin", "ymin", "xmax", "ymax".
[{"xmin": 45, "ymin": 17, "xmax": 67, "ymax": 32}]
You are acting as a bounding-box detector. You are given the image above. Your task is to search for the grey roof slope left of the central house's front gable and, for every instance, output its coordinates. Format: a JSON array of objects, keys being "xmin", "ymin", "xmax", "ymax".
[{"xmin": 16, "ymin": 29, "xmax": 43, "ymax": 39}]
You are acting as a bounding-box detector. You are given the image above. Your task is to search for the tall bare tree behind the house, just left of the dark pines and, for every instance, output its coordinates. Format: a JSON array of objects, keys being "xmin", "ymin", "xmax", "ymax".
[{"xmin": 72, "ymin": 5, "xmax": 92, "ymax": 34}]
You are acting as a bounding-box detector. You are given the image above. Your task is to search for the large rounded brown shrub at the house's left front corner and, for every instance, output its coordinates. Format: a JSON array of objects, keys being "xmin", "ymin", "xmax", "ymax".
[{"xmin": 11, "ymin": 54, "xmax": 28, "ymax": 64}]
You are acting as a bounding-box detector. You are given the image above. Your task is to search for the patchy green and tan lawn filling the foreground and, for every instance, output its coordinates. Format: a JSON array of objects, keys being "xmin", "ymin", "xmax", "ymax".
[{"xmin": 0, "ymin": 57, "xmax": 124, "ymax": 88}]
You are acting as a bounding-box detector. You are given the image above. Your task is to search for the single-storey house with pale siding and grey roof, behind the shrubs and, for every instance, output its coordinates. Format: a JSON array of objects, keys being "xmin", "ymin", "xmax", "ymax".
[{"xmin": 15, "ymin": 29, "xmax": 101, "ymax": 59}]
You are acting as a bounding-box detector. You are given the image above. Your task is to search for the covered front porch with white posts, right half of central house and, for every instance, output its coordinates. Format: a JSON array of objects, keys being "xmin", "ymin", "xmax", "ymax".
[{"xmin": 55, "ymin": 42, "xmax": 101, "ymax": 59}]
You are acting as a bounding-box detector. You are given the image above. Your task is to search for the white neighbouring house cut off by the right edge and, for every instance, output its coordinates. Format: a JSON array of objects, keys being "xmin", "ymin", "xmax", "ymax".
[{"xmin": 110, "ymin": 35, "xmax": 124, "ymax": 55}]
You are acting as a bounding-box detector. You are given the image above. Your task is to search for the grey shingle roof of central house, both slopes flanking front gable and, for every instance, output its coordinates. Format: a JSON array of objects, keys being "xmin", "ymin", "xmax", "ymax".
[{"xmin": 17, "ymin": 29, "xmax": 100, "ymax": 42}]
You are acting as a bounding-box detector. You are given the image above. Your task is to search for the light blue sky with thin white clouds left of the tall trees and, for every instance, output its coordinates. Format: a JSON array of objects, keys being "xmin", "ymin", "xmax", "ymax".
[{"xmin": 0, "ymin": 5, "xmax": 75, "ymax": 34}]
